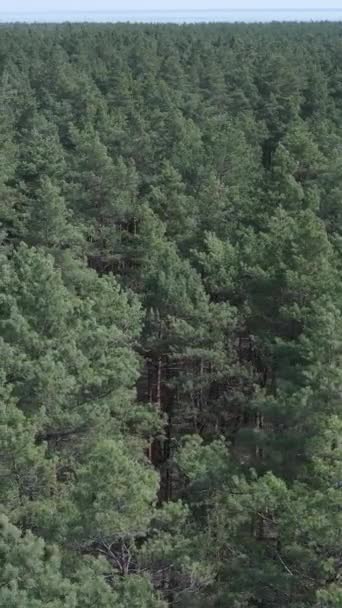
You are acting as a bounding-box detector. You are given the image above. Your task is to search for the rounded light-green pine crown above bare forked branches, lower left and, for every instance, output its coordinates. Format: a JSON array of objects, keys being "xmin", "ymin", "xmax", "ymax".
[{"xmin": 71, "ymin": 439, "xmax": 158, "ymax": 539}]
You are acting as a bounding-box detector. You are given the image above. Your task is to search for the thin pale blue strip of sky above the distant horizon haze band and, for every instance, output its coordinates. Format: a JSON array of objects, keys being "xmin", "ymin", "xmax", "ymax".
[{"xmin": 0, "ymin": 0, "xmax": 342, "ymax": 12}]
